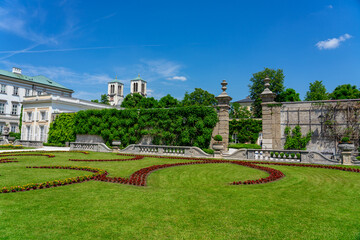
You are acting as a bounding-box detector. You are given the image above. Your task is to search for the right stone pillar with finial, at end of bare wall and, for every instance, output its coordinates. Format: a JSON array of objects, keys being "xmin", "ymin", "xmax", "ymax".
[{"xmin": 260, "ymin": 77, "xmax": 281, "ymax": 149}]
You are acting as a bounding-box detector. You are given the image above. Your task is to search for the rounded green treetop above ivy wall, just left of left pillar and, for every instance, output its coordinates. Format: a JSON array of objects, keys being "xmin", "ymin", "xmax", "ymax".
[{"xmin": 181, "ymin": 88, "xmax": 217, "ymax": 106}]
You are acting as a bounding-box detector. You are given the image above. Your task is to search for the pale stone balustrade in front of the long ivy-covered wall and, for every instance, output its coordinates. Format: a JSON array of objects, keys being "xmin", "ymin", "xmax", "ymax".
[{"xmin": 120, "ymin": 144, "xmax": 212, "ymax": 157}]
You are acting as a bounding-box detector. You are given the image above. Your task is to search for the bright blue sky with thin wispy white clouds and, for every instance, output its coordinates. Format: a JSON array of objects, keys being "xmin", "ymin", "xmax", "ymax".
[{"xmin": 0, "ymin": 0, "xmax": 360, "ymax": 100}]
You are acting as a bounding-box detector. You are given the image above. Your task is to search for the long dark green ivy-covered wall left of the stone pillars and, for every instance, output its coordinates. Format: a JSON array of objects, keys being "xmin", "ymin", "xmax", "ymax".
[{"xmin": 49, "ymin": 106, "xmax": 218, "ymax": 148}]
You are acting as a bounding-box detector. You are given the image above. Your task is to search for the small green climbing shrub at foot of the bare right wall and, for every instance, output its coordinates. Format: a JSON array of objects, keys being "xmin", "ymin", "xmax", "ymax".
[{"xmin": 284, "ymin": 126, "xmax": 312, "ymax": 150}]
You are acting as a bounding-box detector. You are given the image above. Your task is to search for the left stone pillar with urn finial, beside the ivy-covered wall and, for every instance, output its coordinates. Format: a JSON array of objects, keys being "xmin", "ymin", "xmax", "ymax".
[{"xmin": 211, "ymin": 80, "xmax": 232, "ymax": 151}]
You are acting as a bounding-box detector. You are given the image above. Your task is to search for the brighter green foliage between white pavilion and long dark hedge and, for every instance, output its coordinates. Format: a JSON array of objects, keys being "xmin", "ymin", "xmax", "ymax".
[{"xmin": 48, "ymin": 113, "xmax": 77, "ymax": 144}]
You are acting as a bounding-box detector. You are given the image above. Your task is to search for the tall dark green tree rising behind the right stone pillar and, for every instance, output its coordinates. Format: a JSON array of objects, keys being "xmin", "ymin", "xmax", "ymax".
[{"xmin": 249, "ymin": 68, "xmax": 285, "ymax": 118}]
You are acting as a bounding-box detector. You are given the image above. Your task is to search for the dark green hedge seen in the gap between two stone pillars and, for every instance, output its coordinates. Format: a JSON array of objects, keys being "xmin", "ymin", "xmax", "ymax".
[{"xmin": 229, "ymin": 119, "xmax": 262, "ymax": 144}]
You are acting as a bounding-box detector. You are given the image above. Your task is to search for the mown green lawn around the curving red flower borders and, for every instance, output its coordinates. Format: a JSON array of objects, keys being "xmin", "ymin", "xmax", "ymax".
[{"xmin": 0, "ymin": 153, "xmax": 360, "ymax": 239}]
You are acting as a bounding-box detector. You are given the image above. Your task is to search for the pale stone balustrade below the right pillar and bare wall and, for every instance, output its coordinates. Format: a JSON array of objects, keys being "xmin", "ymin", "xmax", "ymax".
[{"xmin": 225, "ymin": 149, "xmax": 341, "ymax": 164}]
